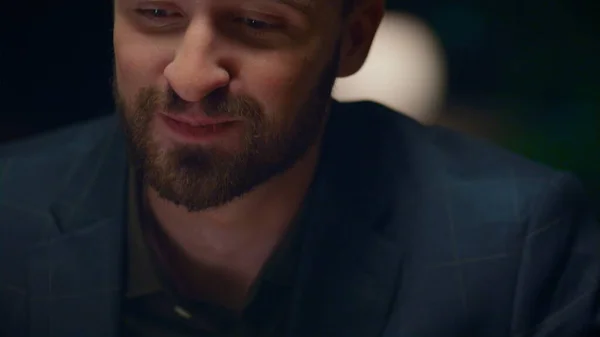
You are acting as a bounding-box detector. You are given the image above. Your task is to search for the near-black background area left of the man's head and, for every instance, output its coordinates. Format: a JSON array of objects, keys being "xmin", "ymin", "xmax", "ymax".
[{"xmin": 0, "ymin": 0, "xmax": 112, "ymax": 140}]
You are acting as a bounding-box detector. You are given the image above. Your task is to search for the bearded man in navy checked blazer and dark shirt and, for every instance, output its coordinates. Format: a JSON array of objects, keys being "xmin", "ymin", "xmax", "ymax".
[{"xmin": 0, "ymin": 0, "xmax": 600, "ymax": 337}]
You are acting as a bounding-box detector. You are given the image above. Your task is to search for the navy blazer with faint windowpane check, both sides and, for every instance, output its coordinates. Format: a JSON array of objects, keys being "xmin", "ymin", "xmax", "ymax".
[{"xmin": 0, "ymin": 102, "xmax": 600, "ymax": 337}]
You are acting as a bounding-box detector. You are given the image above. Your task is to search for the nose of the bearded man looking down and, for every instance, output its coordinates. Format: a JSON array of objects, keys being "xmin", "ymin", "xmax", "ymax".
[{"xmin": 164, "ymin": 22, "xmax": 230, "ymax": 102}]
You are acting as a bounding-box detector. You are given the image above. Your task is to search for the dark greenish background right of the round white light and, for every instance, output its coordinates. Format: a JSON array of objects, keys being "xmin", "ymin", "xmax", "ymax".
[{"xmin": 390, "ymin": 0, "xmax": 600, "ymax": 205}]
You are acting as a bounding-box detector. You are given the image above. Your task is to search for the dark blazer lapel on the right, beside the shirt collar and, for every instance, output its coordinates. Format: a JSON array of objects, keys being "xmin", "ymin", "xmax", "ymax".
[{"xmin": 288, "ymin": 101, "xmax": 402, "ymax": 337}]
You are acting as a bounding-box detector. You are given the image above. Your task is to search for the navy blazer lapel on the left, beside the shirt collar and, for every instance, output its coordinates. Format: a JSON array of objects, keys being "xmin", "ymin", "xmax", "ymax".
[{"xmin": 29, "ymin": 117, "xmax": 127, "ymax": 337}]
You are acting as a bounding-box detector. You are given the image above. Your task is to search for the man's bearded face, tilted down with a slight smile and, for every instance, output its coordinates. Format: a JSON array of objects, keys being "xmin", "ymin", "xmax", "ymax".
[{"xmin": 114, "ymin": 0, "xmax": 350, "ymax": 211}]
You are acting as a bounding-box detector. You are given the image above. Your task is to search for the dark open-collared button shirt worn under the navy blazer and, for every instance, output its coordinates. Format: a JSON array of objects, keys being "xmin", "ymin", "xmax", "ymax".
[{"xmin": 123, "ymin": 169, "xmax": 301, "ymax": 337}]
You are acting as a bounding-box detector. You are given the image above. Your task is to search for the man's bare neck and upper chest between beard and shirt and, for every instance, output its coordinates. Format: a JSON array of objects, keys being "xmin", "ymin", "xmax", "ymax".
[{"xmin": 146, "ymin": 140, "xmax": 319, "ymax": 310}]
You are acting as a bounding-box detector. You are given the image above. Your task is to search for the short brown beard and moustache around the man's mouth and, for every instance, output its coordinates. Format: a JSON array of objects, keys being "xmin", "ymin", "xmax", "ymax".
[{"xmin": 113, "ymin": 44, "xmax": 339, "ymax": 212}]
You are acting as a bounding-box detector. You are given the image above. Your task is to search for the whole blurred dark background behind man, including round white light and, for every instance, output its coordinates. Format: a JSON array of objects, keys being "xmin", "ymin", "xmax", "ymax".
[{"xmin": 0, "ymin": 0, "xmax": 600, "ymax": 210}]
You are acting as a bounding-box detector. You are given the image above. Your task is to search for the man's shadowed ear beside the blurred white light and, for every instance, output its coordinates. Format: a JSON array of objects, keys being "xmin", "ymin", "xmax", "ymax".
[{"xmin": 338, "ymin": 0, "xmax": 385, "ymax": 77}]
